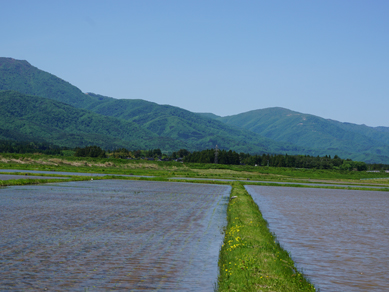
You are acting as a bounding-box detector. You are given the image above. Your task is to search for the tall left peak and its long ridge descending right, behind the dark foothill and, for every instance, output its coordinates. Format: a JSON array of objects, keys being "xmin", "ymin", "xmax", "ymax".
[{"xmin": 0, "ymin": 58, "xmax": 313, "ymax": 153}]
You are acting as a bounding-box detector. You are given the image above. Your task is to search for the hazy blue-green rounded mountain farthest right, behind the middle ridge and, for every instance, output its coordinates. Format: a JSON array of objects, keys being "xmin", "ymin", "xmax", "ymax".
[{"xmin": 216, "ymin": 107, "xmax": 389, "ymax": 163}]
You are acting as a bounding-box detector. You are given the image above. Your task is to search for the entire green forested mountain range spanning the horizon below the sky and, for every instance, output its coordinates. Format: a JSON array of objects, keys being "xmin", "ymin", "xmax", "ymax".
[{"xmin": 0, "ymin": 58, "xmax": 389, "ymax": 163}]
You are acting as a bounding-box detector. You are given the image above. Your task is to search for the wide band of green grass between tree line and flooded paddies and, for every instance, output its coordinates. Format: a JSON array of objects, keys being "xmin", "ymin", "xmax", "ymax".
[{"xmin": 0, "ymin": 153, "xmax": 389, "ymax": 186}]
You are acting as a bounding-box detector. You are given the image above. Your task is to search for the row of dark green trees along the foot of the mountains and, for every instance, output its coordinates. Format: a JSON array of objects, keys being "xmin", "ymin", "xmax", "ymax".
[{"xmin": 0, "ymin": 140, "xmax": 389, "ymax": 171}]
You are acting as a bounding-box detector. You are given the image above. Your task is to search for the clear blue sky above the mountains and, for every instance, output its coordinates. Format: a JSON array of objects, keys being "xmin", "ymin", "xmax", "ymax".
[{"xmin": 0, "ymin": 0, "xmax": 389, "ymax": 126}]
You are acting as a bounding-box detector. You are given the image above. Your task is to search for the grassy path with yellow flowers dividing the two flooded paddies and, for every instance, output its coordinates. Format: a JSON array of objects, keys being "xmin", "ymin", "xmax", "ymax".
[{"xmin": 218, "ymin": 182, "xmax": 315, "ymax": 291}]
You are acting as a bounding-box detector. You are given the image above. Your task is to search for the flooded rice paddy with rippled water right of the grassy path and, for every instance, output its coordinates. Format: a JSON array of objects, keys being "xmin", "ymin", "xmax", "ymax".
[{"xmin": 246, "ymin": 186, "xmax": 389, "ymax": 291}]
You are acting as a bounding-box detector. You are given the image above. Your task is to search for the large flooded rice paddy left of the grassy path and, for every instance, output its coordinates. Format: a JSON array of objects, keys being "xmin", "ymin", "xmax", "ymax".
[{"xmin": 0, "ymin": 180, "xmax": 230, "ymax": 291}]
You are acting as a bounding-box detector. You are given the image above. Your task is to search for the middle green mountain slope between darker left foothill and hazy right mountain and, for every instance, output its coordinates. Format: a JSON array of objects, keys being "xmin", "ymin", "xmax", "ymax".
[{"xmin": 82, "ymin": 93, "xmax": 308, "ymax": 153}]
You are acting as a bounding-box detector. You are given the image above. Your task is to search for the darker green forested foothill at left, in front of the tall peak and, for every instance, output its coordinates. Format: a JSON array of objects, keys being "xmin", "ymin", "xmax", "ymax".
[{"xmin": 0, "ymin": 91, "xmax": 186, "ymax": 149}]
